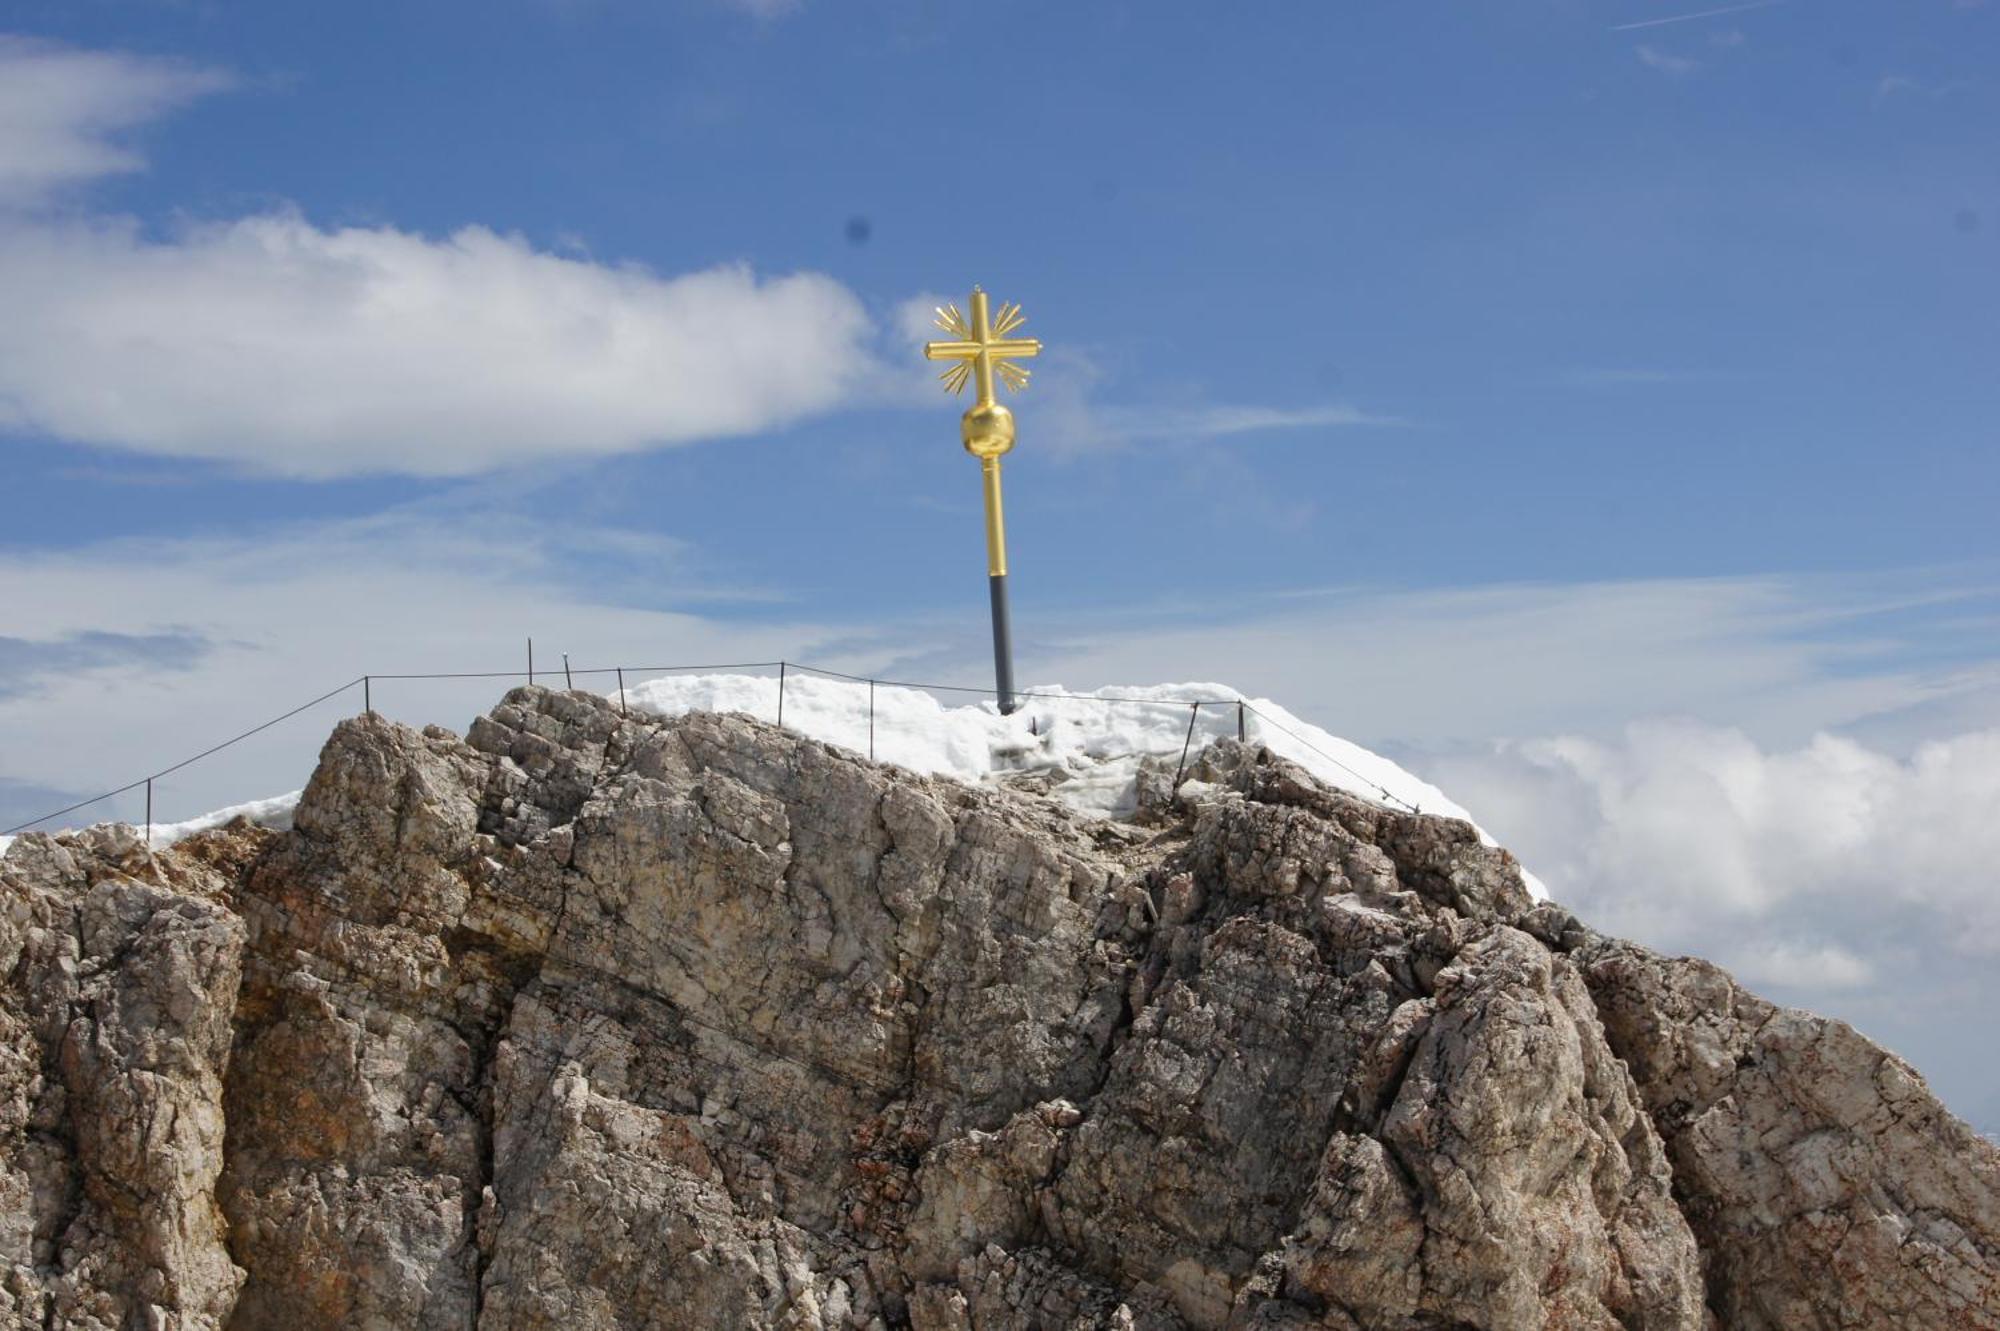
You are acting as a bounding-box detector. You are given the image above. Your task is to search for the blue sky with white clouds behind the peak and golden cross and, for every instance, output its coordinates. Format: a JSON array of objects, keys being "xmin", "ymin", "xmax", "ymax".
[{"xmin": 0, "ymin": 0, "xmax": 2000, "ymax": 1123}]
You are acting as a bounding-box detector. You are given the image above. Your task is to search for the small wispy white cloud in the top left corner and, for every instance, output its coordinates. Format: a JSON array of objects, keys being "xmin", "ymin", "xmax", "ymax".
[{"xmin": 0, "ymin": 34, "xmax": 230, "ymax": 206}]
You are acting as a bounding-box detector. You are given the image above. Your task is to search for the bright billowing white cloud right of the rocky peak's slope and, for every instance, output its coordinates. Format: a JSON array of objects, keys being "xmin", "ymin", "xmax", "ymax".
[{"xmin": 1460, "ymin": 721, "xmax": 2000, "ymax": 939}]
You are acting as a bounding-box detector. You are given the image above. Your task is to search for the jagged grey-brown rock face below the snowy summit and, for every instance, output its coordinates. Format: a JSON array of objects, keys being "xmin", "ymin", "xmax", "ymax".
[{"xmin": 0, "ymin": 689, "xmax": 2000, "ymax": 1331}]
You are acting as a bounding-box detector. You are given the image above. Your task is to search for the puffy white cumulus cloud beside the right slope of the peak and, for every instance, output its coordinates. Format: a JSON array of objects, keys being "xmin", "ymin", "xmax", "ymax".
[{"xmin": 1430, "ymin": 721, "xmax": 2000, "ymax": 959}]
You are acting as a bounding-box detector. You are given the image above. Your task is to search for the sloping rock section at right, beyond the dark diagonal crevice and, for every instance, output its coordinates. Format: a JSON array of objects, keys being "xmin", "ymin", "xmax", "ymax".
[{"xmin": 1578, "ymin": 939, "xmax": 2000, "ymax": 1331}]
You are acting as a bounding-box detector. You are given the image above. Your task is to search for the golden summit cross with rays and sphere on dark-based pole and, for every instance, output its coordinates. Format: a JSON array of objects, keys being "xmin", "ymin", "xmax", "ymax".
[{"xmin": 924, "ymin": 288, "xmax": 1042, "ymax": 715}]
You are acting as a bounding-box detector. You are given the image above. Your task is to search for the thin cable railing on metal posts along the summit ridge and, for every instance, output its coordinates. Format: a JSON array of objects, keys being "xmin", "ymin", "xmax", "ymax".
[{"xmin": 0, "ymin": 642, "xmax": 1422, "ymax": 845}]
